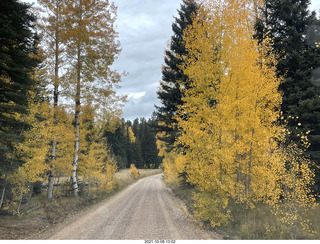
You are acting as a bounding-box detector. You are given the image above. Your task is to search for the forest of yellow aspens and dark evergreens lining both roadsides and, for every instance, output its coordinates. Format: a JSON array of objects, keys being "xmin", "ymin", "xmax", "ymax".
[{"xmin": 0, "ymin": 0, "xmax": 320, "ymax": 239}]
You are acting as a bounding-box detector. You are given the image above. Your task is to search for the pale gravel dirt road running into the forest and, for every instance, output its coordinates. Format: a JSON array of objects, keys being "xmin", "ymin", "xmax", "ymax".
[{"xmin": 45, "ymin": 174, "xmax": 220, "ymax": 240}]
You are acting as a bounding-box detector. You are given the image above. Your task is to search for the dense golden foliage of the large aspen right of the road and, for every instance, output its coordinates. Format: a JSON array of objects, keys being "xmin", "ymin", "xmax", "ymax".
[{"xmin": 177, "ymin": 0, "xmax": 281, "ymax": 210}]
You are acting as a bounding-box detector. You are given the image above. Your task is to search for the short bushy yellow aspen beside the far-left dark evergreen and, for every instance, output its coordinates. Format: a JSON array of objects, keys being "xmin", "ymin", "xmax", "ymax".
[{"xmin": 4, "ymin": 92, "xmax": 52, "ymax": 214}]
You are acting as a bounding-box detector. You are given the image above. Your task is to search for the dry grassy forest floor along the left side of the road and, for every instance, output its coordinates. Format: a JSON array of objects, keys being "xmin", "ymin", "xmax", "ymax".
[{"xmin": 0, "ymin": 169, "xmax": 162, "ymax": 240}]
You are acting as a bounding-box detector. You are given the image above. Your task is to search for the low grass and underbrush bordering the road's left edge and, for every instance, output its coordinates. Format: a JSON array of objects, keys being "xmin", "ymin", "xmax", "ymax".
[{"xmin": 0, "ymin": 169, "xmax": 162, "ymax": 240}]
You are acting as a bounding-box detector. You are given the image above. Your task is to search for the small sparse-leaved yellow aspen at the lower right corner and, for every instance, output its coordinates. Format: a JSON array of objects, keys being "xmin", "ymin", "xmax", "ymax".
[{"xmin": 268, "ymin": 129, "xmax": 318, "ymax": 240}]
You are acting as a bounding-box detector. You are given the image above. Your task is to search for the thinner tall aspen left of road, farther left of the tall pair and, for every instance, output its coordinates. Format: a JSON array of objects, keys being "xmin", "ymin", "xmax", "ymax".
[{"xmin": 38, "ymin": 0, "xmax": 70, "ymax": 200}]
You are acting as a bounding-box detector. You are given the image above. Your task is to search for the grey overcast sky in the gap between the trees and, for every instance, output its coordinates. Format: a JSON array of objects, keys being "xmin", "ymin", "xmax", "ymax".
[{"xmin": 23, "ymin": 0, "xmax": 320, "ymax": 120}]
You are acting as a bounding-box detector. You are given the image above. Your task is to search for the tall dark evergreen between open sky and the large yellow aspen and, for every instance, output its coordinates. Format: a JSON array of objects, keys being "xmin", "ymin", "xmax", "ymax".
[{"xmin": 156, "ymin": 0, "xmax": 198, "ymax": 150}]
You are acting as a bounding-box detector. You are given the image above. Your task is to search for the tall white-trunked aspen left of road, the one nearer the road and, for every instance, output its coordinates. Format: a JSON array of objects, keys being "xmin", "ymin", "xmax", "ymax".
[{"xmin": 65, "ymin": 0, "xmax": 122, "ymax": 196}]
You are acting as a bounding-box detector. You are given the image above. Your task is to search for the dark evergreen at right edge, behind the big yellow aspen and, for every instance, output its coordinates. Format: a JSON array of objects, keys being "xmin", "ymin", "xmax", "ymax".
[{"xmin": 256, "ymin": 0, "xmax": 320, "ymax": 191}]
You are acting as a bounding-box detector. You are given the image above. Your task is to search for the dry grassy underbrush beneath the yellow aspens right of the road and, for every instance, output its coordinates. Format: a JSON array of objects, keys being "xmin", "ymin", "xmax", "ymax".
[{"xmin": 168, "ymin": 183, "xmax": 320, "ymax": 240}]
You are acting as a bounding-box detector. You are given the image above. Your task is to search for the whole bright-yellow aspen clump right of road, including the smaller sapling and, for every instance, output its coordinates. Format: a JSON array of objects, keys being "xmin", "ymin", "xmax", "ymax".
[{"xmin": 159, "ymin": 0, "xmax": 313, "ymax": 236}]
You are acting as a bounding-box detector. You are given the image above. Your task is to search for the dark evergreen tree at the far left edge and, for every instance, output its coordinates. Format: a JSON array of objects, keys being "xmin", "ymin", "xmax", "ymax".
[{"xmin": 0, "ymin": 0, "xmax": 38, "ymax": 207}]
